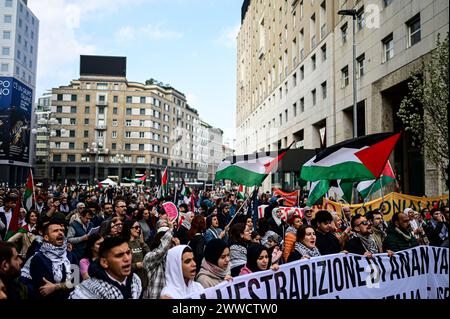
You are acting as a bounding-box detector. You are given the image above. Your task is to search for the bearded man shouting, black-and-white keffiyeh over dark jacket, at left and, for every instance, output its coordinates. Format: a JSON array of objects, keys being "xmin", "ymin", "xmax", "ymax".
[{"xmin": 29, "ymin": 218, "xmax": 78, "ymax": 299}]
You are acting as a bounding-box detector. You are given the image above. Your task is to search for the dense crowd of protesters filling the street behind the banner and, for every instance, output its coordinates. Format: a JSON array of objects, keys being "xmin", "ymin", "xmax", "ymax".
[{"xmin": 0, "ymin": 182, "xmax": 449, "ymax": 300}]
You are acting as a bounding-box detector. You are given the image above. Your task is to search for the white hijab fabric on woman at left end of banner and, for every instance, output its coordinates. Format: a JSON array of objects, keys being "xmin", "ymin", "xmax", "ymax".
[{"xmin": 161, "ymin": 245, "xmax": 203, "ymax": 299}]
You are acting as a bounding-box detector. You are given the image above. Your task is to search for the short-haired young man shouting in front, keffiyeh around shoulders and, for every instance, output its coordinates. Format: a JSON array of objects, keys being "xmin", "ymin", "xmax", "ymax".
[{"xmin": 69, "ymin": 237, "xmax": 142, "ymax": 299}]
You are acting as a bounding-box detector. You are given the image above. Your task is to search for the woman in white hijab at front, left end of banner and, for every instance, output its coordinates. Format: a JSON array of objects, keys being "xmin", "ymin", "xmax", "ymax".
[{"xmin": 161, "ymin": 245, "xmax": 203, "ymax": 299}]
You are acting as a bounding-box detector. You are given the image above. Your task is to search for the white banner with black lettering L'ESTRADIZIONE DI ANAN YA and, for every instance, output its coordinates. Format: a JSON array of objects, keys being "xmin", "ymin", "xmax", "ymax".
[{"xmin": 190, "ymin": 246, "xmax": 450, "ymax": 299}]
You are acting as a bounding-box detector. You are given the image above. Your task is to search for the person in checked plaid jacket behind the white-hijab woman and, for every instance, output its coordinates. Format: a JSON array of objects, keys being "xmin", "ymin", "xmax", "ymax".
[{"xmin": 143, "ymin": 219, "xmax": 180, "ymax": 299}]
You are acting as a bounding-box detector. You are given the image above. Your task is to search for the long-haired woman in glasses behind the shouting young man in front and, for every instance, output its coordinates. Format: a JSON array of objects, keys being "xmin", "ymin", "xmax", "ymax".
[{"xmin": 122, "ymin": 219, "xmax": 150, "ymax": 290}]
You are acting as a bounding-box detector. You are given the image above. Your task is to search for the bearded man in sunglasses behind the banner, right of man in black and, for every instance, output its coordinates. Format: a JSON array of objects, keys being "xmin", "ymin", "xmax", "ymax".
[{"xmin": 345, "ymin": 214, "xmax": 393, "ymax": 257}]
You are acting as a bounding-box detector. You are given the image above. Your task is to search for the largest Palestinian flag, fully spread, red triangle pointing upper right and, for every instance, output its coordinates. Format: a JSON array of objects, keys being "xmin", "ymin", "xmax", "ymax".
[{"xmin": 300, "ymin": 133, "xmax": 400, "ymax": 182}]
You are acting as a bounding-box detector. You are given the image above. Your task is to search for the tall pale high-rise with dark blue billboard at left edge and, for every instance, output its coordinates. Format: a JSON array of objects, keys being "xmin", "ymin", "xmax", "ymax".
[{"xmin": 0, "ymin": 0, "xmax": 39, "ymax": 185}]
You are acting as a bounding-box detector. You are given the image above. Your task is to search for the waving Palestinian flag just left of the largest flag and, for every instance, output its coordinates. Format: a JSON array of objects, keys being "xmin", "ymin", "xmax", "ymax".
[{"xmin": 215, "ymin": 144, "xmax": 292, "ymax": 187}]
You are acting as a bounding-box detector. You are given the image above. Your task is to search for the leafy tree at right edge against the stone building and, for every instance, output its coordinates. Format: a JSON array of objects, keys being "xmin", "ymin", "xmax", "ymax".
[{"xmin": 397, "ymin": 33, "xmax": 449, "ymax": 188}]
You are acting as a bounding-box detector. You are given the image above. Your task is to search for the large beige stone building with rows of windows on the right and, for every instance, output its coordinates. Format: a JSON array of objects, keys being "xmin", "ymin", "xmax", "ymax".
[{"xmin": 236, "ymin": 0, "xmax": 449, "ymax": 196}]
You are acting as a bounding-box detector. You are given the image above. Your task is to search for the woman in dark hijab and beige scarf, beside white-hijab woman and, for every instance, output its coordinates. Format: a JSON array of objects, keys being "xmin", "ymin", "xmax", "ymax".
[{"xmin": 196, "ymin": 238, "xmax": 233, "ymax": 288}]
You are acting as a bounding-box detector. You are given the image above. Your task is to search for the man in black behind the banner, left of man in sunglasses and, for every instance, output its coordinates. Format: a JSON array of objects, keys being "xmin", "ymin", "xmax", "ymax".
[{"xmin": 313, "ymin": 210, "xmax": 341, "ymax": 255}]
